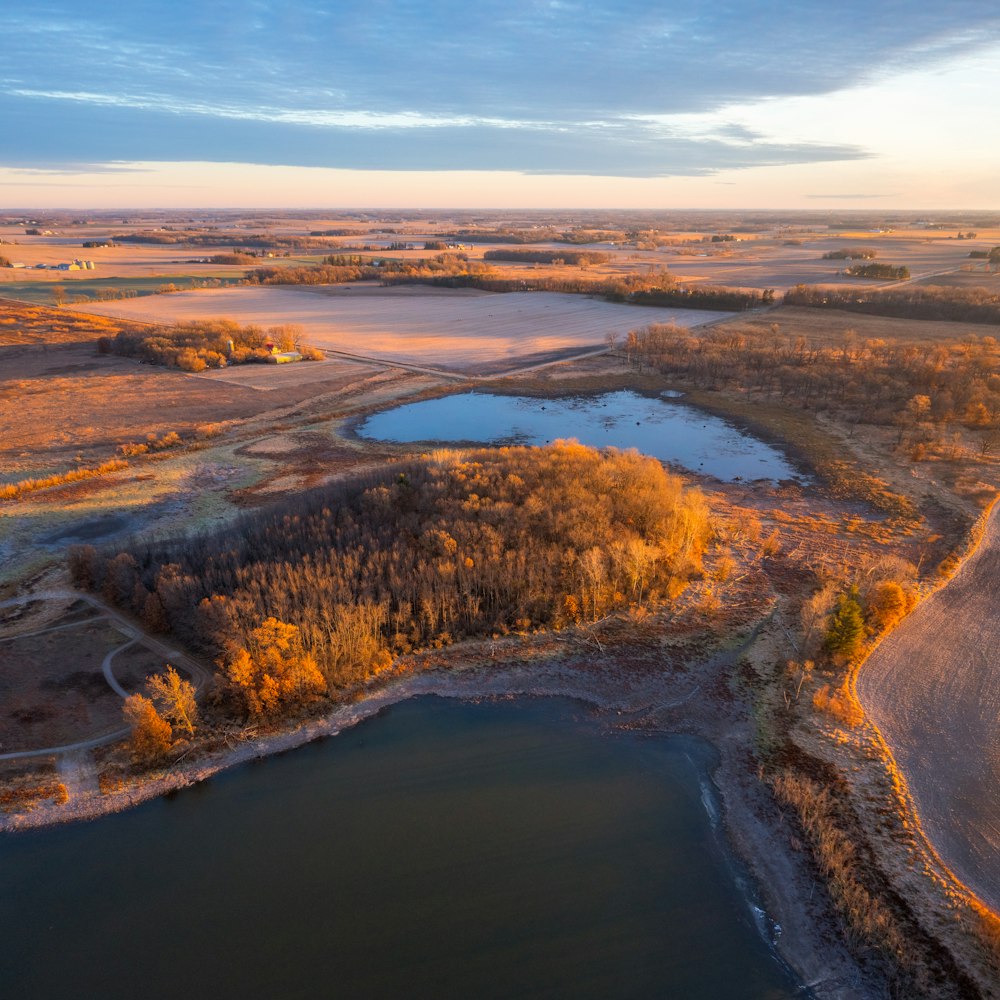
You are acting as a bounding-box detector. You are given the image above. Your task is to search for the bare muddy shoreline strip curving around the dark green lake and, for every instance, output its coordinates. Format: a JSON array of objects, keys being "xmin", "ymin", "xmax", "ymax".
[{"xmin": 0, "ymin": 649, "xmax": 872, "ymax": 1000}]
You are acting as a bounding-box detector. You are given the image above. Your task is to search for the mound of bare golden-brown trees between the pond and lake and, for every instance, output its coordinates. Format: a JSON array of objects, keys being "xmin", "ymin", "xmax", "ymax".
[{"xmin": 71, "ymin": 442, "xmax": 710, "ymax": 704}]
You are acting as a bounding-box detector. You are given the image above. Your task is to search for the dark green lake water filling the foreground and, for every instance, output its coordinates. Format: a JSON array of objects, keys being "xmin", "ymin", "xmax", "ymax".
[{"xmin": 0, "ymin": 698, "xmax": 797, "ymax": 1000}]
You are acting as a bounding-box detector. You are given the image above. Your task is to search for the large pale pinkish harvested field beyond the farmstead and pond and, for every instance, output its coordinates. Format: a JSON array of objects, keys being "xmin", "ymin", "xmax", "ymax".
[{"xmin": 74, "ymin": 285, "xmax": 730, "ymax": 374}]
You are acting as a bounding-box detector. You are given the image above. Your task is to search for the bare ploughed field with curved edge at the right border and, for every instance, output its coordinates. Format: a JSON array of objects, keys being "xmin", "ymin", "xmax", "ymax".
[{"xmin": 857, "ymin": 503, "xmax": 1000, "ymax": 911}]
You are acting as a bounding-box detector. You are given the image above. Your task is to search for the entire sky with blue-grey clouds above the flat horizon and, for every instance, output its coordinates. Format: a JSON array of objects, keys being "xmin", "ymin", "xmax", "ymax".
[{"xmin": 0, "ymin": 0, "xmax": 1000, "ymax": 210}]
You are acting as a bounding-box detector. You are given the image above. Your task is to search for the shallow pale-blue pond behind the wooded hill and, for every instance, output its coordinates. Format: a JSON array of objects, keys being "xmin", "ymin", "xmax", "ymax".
[{"xmin": 357, "ymin": 391, "xmax": 797, "ymax": 481}]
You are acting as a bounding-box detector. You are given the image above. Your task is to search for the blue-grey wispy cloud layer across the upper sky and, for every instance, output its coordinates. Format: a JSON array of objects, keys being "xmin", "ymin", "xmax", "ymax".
[{"xmin": 0, "ymin": 0, "xmax": 1000, "ymax": 176}]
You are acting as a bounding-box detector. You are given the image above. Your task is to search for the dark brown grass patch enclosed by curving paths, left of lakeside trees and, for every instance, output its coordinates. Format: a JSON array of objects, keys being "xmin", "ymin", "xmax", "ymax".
[{"xmin": 0, "ymin": 619, "xmax": 127, "ymax": 753}]
